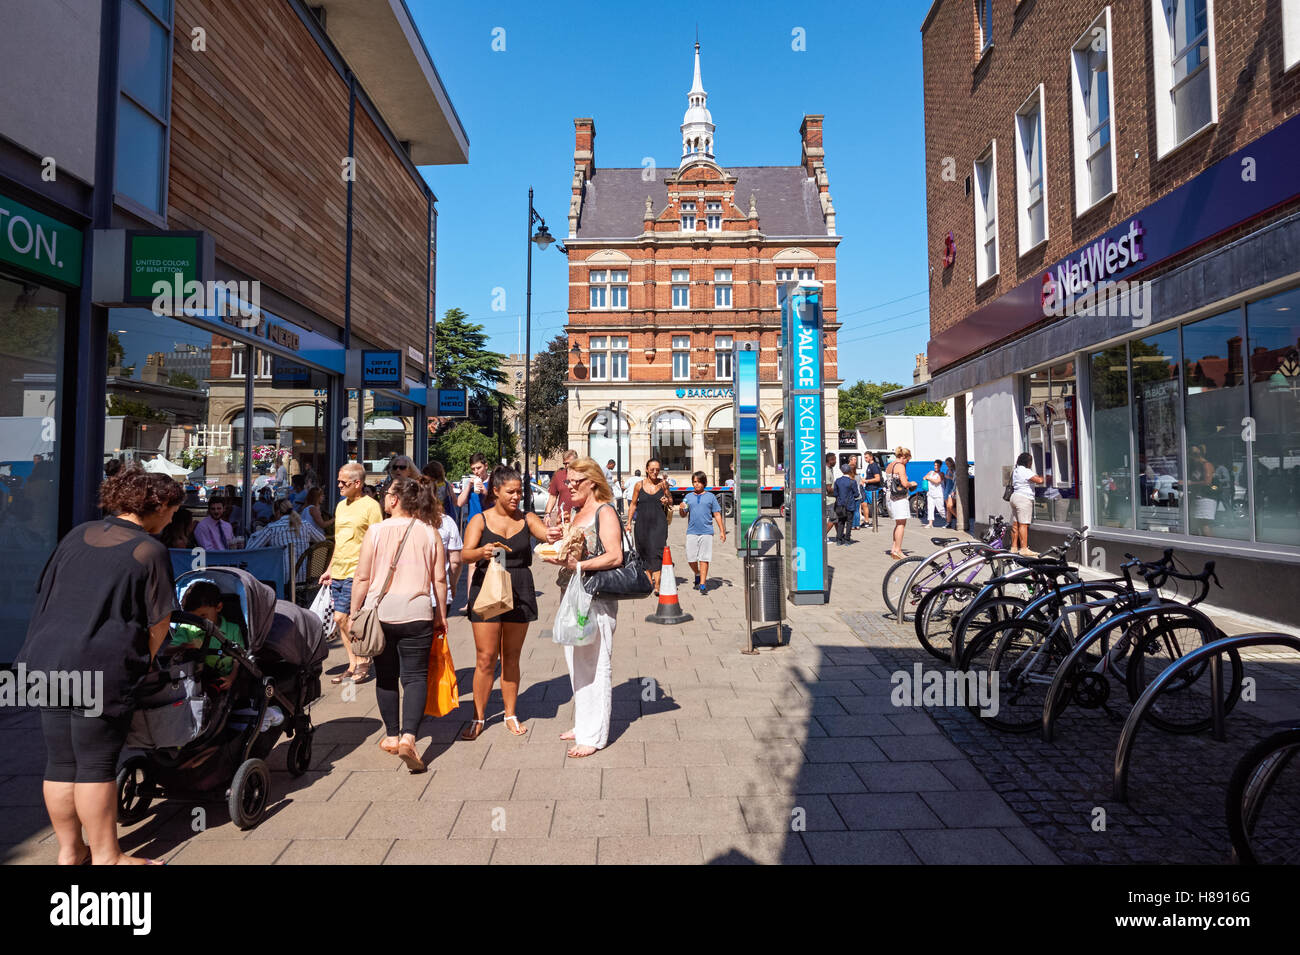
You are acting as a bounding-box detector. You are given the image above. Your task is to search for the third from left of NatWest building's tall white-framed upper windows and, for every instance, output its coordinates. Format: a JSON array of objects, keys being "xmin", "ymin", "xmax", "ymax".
[{"xmin": 1070, "ymin": 6, "xmax": 1115, "ymax": 216}]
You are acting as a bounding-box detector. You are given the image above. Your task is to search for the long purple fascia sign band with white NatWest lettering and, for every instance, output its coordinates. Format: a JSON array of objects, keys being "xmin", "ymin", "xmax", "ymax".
[{"xmin": 928, "ymin": 109, "xmax": 1300, "ymax": 373}]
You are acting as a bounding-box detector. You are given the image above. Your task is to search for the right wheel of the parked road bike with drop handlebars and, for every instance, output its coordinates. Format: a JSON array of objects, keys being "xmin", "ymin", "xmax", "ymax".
[{"xmin": 1125, "ymin": 616, "xmax": 1242, "ymax": 733}]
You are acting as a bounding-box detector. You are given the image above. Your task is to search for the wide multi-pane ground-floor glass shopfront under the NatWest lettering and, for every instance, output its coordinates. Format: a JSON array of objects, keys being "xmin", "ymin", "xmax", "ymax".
[{"xmin": 1088, "ymin": 288, "xmax": 1300, "ymax": 547}]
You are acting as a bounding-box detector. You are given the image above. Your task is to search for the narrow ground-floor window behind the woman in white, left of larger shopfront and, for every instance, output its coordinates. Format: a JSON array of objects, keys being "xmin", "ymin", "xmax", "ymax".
[{"xmin": 1022, "ymin": 361, "xmax": 1080, "ymax": 526}]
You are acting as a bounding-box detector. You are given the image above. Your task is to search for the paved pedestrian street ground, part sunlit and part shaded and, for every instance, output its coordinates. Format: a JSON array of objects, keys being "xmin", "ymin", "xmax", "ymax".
[{"xmin": 0, "ymin": 521, "xmax": 1300, "ymax": 864}]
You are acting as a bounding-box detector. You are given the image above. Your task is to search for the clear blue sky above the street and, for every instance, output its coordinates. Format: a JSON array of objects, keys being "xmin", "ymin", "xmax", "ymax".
[{"xmin": 407, "ymin": 0, "xmax": 930, "ymax": 385}]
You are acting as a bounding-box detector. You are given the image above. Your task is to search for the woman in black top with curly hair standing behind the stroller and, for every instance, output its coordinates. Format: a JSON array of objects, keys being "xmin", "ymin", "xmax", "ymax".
[{"xmin": 17, "ymin": 464, "xmax": 185, "ymax": 865}]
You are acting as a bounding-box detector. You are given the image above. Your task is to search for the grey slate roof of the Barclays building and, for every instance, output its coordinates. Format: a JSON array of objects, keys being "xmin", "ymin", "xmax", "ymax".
[{"xmin": 577, "ymin": 166, "xmax": 826, "ymax": 239}]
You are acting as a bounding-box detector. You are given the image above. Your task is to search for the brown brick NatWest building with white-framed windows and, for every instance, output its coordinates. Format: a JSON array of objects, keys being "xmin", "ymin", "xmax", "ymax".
[{"xmin": 922, "ymin": 0, "xmax": 1300, "ymax": 613}]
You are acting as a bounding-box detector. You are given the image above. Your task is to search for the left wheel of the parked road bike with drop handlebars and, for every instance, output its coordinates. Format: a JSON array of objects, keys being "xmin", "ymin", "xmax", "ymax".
[{"xmin": 975, "ymin": 620, "xmax": 1070, "ymax": 733}]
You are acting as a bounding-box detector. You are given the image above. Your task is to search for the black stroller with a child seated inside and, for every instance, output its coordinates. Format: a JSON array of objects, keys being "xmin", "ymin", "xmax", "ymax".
[{"xmin": 117, "ymin": 568, "xmax": 329, "ymax": 829}]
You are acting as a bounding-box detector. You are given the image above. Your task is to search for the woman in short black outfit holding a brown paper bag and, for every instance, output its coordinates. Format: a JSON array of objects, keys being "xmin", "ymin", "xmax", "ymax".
[{"xmin": 460, "ymin": 468, "xmax": 560, "ymax": 739}]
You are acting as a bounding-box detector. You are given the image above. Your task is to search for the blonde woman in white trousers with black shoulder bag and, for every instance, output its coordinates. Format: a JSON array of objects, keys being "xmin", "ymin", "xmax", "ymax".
[{"xmin": 546, "ymin": 457, "xmax": 623, "ymax": 759}]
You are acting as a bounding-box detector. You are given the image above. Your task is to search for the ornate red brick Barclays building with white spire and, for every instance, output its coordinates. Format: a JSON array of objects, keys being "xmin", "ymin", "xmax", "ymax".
[{"xmin": 564, "ymin": 44, "xmax": 840, "ymax": 483}]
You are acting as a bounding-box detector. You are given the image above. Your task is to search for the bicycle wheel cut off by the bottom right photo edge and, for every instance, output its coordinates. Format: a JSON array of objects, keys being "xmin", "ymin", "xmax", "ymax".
[{"xmin": 1227, "ymin": 729, "xmax": 1300, "ymax": 865}]
